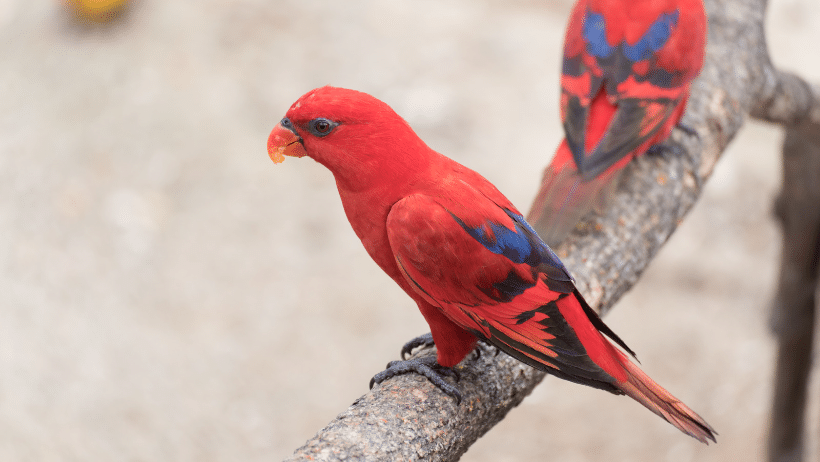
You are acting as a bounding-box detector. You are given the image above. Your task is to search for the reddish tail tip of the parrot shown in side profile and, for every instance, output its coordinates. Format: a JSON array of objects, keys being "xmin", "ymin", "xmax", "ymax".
[{"xmin": 616, "ymin": 351, "xmax": 717, "ymax": 444}]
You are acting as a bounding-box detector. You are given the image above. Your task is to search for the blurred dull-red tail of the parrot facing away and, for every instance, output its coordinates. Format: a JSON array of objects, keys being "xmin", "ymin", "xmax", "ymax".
[{"xmin": 527, "ymin": 140, "xmax": 615, "ymax": 247}]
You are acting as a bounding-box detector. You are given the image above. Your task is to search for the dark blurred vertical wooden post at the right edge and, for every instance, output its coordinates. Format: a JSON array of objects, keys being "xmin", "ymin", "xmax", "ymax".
[{"xmin": 769, "ymin": 123, "xmax": 820, "ymax": 462}]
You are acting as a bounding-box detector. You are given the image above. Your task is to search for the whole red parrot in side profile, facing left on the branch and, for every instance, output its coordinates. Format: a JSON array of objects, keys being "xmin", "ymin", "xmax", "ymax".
[{"xmin": 268, "ymin": 87, "xmax": 715, "ymax": 443}]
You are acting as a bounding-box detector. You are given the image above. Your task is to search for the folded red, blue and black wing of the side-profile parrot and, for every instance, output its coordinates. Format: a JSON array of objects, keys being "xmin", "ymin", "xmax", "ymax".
[{"xmin": 387, "ymin": 194, "xmax": 625, "ymax": 392}]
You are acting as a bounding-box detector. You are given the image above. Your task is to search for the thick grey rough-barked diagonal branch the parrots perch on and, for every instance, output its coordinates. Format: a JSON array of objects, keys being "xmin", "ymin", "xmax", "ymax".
[{"xmin": 288, "ymin": 0, "xmax": 820, "ymax": 460}]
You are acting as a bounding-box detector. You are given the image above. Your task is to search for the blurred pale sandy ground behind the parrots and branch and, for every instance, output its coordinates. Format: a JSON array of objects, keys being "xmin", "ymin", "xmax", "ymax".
[{"xmin": 0, "ymin": 0, "xmax": 820, "ymax": 462}]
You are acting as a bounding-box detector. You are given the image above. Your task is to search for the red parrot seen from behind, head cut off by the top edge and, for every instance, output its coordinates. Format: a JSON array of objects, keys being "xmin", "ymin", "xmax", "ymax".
[{"xmin": 527, "ymin": 0, "xmax": 707, "ymax": 246}]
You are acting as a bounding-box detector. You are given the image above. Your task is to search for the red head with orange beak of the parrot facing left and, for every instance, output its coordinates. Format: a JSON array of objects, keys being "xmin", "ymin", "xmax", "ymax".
[{"xmin": 268, "ymin": 87, "xmax": 432, "ymax": 189}]
